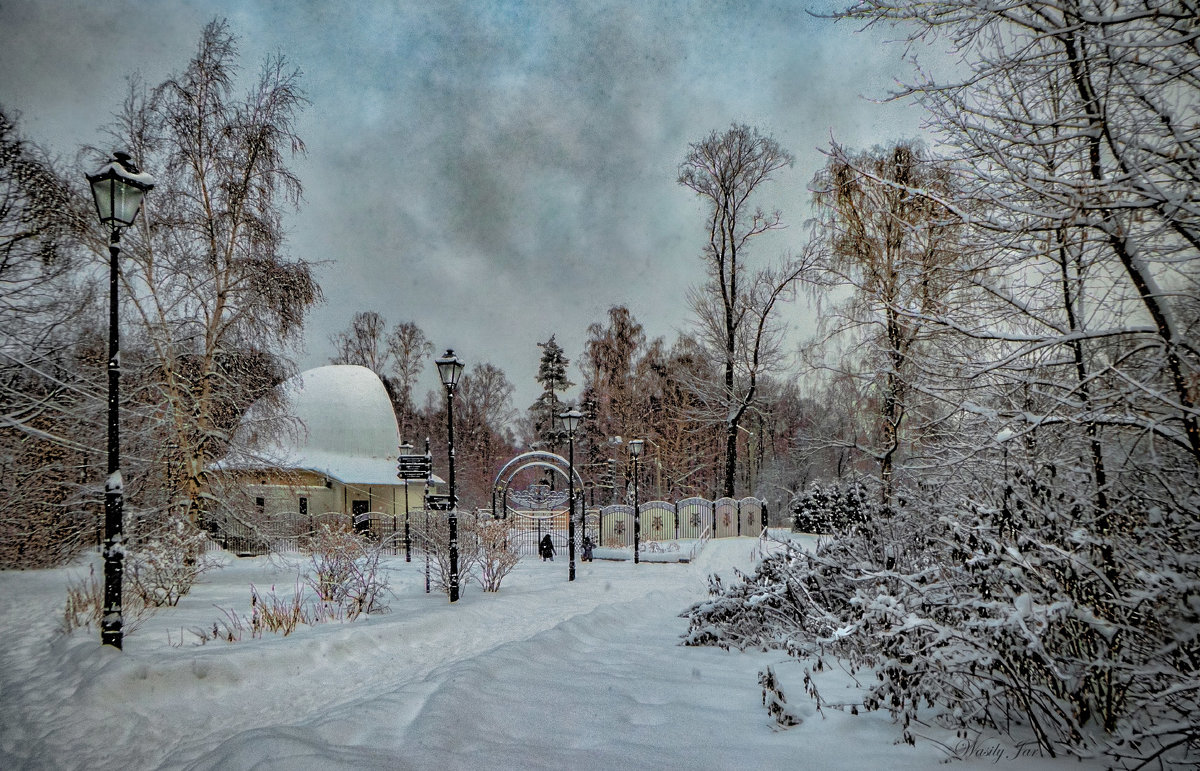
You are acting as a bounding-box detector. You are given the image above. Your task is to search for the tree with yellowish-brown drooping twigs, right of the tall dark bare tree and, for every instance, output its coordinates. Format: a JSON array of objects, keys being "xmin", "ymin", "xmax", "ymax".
[{"xmin": 808, "ymin": 142, "xmax": 960, "ymax": 503}]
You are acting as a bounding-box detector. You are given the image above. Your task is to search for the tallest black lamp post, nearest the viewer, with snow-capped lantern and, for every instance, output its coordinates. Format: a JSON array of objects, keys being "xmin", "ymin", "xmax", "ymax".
[{"xmin": 85, "ymin": 153, "xmax": 154, "ymax": 650}]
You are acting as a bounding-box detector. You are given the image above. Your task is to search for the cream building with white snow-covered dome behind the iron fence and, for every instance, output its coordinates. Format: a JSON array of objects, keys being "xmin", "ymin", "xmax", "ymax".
[{"xmin": 214, "ymin": 365, "xmax": 442, "ymax": 531}]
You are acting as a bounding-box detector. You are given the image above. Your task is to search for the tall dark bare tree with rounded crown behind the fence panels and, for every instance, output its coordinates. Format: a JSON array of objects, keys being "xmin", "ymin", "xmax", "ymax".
[{"xmin": 679, "ymin": 124, "xmax": 802, "ymax": 496}]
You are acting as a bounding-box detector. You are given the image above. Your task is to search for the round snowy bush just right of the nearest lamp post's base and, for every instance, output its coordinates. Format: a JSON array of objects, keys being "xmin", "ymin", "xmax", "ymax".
[{"xmin": 125, "ymin": 515, "xmax": 214, "ymax": 606}]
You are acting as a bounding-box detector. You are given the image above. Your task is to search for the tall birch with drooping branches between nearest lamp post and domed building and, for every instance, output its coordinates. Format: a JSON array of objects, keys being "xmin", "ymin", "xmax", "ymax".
[{"xmin": 103, "ymin": 22, "xmax": 320, "ymax": 524}]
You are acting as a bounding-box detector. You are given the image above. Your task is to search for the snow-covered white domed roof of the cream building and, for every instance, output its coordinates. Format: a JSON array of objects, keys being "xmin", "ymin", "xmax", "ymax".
[{"xmin": 216, "ymin": 364, "xmax": 412, "ymax": 484}]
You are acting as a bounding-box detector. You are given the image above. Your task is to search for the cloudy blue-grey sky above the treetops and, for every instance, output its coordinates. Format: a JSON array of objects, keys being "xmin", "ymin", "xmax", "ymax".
[{"xmin": 0, "ymin": 0, "xmax": 922, "ymax": 408}]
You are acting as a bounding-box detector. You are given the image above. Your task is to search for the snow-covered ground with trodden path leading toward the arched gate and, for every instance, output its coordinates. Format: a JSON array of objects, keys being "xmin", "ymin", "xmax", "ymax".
[{"xmin": 0, "ymin": 538, "xmax": 1086, "ymax": 770}]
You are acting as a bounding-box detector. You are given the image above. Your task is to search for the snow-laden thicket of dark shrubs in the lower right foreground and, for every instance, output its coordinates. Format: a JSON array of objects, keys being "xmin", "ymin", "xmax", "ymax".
[{"xmin": 684, "ymin": 467, "xmax": 1200, "ymax": 765}]
